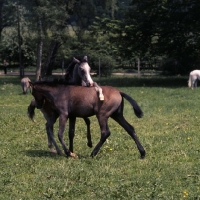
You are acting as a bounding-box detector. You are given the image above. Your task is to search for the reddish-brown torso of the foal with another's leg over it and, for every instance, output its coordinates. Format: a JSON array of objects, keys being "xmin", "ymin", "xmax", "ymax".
[{"xmin": 49, "ymin": 85, "xmax": 122, "ymax": 117}]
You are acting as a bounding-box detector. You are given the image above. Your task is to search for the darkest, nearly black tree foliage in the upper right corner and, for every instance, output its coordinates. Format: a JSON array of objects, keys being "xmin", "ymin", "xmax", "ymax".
[{"xmin": 124, "ymin": 0, "xmax": 200, "ymax": 73}]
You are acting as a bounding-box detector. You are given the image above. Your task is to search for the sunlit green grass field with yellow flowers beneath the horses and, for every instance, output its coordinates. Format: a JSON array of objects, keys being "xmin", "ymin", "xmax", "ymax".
[{"xmin": 0, "ymin": 76, "xmax": 200, "ymax": 200}]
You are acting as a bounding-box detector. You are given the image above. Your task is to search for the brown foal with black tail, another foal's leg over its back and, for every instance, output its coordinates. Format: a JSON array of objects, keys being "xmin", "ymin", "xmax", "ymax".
[{"xmin": 30, "ymin": 82, "xmax": 145, "ymax": 158}]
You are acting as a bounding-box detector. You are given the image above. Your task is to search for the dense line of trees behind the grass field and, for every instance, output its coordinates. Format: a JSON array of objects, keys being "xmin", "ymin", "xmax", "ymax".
[{"xmin": 0, "ymin": 0, "xmax": 200, "ymax": 79}]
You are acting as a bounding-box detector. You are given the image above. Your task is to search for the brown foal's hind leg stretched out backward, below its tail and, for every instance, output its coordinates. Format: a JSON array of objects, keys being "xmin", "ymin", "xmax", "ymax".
[{"xmin": 111, "ymin": 115, "xmax": 146, "ymax": 158}]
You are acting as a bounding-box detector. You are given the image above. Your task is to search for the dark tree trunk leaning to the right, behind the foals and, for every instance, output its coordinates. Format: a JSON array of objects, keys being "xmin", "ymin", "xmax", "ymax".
[{"xmin": 41, "ymin": 40, "xmax": 61, "ymax": 78}]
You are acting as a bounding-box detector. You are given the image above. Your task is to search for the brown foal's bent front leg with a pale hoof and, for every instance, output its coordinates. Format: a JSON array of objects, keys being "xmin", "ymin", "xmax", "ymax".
[{"xmin": 58, "ymin": 115, "xmax": 76, "ymax": 157}]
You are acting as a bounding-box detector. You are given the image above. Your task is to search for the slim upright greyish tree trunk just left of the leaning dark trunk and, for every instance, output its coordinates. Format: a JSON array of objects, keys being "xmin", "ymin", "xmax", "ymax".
[{"xmin": 36, "ymin": 18, "xmax": 43, "ymax": 81}]
